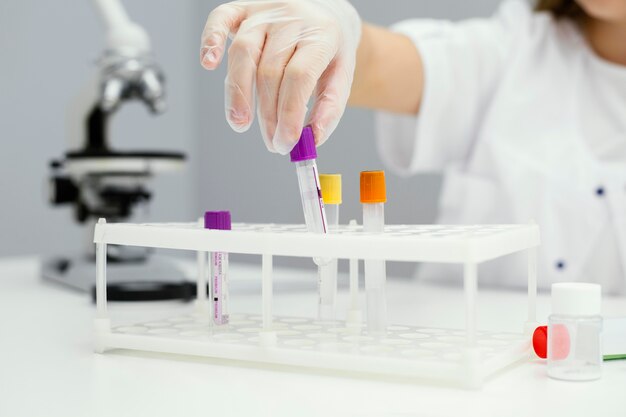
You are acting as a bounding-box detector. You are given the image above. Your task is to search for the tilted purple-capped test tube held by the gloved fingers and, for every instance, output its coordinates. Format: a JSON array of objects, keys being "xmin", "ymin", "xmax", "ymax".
[{"xmin": 290, "ymin": 126, "xmax": 330, "ymax": 265}]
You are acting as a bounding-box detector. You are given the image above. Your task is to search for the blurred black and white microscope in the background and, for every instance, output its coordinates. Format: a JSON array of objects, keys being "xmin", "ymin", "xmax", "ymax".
[{"xmin": 42, "ymin": 0, "xmax": 191, "ymax": 300}]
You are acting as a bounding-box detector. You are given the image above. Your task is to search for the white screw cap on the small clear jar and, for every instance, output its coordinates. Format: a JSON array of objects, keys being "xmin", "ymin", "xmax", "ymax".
[{"xmin": 552, "ymin": 282, "xmax": 602, "ymax": 316}]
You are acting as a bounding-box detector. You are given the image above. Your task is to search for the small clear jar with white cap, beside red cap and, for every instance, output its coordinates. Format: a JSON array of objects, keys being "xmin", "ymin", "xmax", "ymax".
[{"xmin": 548, "ymin": 283, "xmax": 602, "ymax": 381}]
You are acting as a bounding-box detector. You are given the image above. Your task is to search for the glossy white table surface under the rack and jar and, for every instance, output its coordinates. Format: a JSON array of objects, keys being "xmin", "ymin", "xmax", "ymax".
[{"xmin": 0, "ymin": 259, "xmax": 626, "ymax": 417}]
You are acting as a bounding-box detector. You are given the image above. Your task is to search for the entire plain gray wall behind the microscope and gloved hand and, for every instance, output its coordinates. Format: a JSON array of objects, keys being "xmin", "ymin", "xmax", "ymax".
[{"xmin": 0, "ymin": 0, "xmax": 500, "ymax": 264}]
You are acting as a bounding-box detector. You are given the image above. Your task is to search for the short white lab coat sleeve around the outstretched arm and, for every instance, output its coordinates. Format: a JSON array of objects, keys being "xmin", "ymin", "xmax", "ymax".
[{"xmin": 377, "ymin": 0, "xmax": 532, "ymax": 175}]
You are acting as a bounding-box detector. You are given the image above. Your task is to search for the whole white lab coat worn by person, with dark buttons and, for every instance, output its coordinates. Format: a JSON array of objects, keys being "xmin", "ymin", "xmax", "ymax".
[{"xmin": 378, "ymin": 1, "xmax": 626, "ymax": 293}]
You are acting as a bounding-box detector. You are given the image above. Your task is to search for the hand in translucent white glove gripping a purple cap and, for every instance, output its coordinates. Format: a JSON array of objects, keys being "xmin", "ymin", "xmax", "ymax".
[{"xmin": 200, "ymin": 0, "xmax": 361, "ymax": 154}]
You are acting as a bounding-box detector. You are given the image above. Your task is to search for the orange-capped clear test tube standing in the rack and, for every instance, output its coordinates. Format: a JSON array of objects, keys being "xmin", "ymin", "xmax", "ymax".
[{"xmin": 361, "ymin": 171, "xmax": 387, "ymax": 334}]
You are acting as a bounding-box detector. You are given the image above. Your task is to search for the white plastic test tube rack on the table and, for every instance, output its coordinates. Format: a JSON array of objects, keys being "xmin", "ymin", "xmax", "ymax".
[{"xmin": 94, "ymin": 219, "xmax": 540, "ymax": 387}]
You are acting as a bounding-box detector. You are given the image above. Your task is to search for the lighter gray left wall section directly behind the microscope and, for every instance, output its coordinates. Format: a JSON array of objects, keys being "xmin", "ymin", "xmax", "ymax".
[{"xmin": 0, "ymin": 0, "xmax": 200, "ymax": 256}]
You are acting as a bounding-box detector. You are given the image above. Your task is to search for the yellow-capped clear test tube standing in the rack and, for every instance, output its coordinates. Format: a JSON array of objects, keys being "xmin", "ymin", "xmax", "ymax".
[{"xmin": 317, "ymin": 174, "xmax": 341, "ymax": 320}]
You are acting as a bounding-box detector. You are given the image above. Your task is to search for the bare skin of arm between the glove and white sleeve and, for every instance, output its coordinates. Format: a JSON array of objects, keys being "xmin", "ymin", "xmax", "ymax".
[{"xmin": 348, "ymin": 24, "xmax": 424, "ymax": 114}]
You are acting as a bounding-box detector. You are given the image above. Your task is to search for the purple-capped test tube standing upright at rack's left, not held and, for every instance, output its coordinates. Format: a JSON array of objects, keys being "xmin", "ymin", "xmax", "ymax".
[{"xmin": 204, "ymin": 211, "xmax": 231, "ymax": 325}]
